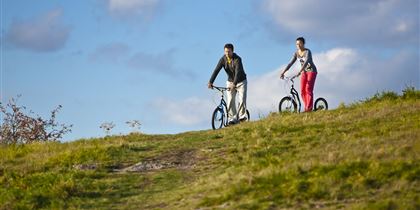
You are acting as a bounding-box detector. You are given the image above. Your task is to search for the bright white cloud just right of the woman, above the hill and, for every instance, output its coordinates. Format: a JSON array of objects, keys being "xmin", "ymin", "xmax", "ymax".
[{"xmin": 314, "ymin": 48, "xmax": 420, "ymax": 96}]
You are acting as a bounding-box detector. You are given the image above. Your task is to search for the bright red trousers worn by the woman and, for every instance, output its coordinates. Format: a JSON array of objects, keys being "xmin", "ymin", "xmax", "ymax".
[{"xmin": 300, "ymin": 71, "xmax": 317, "ymax": 112}]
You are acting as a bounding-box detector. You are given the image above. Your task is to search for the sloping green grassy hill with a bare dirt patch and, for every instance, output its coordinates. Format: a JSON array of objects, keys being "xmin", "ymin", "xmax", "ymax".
[{"xmin": 0, "ymin": 89, "xmax": 420, "ymax": 209}]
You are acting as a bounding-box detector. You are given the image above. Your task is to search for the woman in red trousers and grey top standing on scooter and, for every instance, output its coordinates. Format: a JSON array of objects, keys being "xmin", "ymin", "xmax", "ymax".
[{"xmin": 280, "ymin": 37, "xmax": 317, "ymax": 112}]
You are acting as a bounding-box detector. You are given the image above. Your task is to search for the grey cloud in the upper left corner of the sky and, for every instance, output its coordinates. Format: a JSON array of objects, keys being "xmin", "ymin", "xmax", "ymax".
[{"xmin": 6, "ymin": 9, "xmax": 70, "ymax": 52}]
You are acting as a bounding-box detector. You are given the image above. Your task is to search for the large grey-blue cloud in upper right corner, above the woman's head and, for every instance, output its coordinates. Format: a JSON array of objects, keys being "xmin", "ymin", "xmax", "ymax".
[{"xmin": 262, "ymin": 0, "xmax": 419, "ymax": 47}]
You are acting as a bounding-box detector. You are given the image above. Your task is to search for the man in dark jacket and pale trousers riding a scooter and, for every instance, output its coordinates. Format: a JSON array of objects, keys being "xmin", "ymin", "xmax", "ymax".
[{"xmin": 208, "ymin": 44, "xmax": 247, "ymax": 125}]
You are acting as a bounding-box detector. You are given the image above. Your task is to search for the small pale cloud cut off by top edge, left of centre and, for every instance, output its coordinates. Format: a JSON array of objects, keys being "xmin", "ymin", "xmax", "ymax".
[{"xmin": 108, "ymin": 0, "xmax": 159, "ymax": 18}]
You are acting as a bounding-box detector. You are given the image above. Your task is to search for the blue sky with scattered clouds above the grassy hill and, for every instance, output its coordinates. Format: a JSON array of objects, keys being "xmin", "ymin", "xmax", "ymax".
[{"xmin": 0, "ymin": 0, "xmax": 420, "ymax": 140}]
